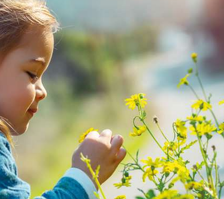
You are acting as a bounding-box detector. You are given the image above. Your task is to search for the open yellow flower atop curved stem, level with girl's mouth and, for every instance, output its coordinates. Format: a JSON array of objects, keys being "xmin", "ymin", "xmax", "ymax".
[{"xmin": 125, "ymin": 93, "xmax": 147, "ymax": 110}]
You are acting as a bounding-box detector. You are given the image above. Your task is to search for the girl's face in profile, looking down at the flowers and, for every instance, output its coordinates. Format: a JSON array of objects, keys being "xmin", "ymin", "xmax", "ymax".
[{"xmin": 0, "ymin": 27, "xmax": 54, "ymax": 135}]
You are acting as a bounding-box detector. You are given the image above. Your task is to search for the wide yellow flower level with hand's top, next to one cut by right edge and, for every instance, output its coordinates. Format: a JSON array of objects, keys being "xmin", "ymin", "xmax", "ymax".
[{"xmin": 189, "ymin": 123, "xmax": 216, "ymax": 136}]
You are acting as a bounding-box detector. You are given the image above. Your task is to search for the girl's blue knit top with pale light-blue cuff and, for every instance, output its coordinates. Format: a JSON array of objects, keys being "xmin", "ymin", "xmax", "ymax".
[{"xmin": 0, "ymin": 132, "xmax": 96, "ymax": 199}]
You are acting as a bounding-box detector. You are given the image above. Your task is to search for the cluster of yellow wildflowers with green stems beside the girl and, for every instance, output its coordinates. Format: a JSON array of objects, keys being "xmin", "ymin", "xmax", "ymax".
[{"xmin": 79, "ymin": 53, "xmax": 224, "ymax": 199}]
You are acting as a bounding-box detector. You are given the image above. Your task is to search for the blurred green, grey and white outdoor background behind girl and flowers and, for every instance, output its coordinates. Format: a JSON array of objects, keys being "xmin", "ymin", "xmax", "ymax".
[{"xmin": 14, "ymin": 0, "xmax": 224, "ymax": 199}]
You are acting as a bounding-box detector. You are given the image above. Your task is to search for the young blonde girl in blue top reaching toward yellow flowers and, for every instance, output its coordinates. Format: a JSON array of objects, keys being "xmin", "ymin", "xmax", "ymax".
[{"xmin": 0, "ymin": 0, "xmax": 125, "ymax": 199}]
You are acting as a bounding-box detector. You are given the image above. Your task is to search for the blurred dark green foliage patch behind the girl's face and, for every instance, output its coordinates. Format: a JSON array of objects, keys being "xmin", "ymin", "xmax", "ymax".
[{"xmin": 48, "ymin": 26, "xmax": 157, "ymax": 95}]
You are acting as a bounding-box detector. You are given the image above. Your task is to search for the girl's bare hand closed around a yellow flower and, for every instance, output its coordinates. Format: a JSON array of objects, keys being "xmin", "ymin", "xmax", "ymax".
[{"xmin": 72, "ymin": 129, "xmax": 126, "ymax": 184}]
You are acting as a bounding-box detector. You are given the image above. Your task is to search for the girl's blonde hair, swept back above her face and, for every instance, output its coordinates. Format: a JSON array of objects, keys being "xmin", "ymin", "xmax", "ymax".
[{"xmin": 0, "ymin": 0, "xmax": 59, "ymax": 144}]
